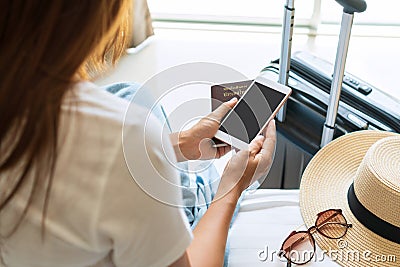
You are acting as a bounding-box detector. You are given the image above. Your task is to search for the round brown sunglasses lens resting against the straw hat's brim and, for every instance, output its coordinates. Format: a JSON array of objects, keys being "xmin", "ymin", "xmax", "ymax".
[{"xmin": 315, "ymin": 210, "xmax": 347, "ymax": 238}]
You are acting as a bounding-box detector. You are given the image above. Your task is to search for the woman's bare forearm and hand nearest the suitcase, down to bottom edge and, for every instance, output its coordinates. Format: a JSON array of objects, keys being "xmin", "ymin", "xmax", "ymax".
[{"xmin": 170, "ymin": 121, "xmax": 276, "ymax": 267}]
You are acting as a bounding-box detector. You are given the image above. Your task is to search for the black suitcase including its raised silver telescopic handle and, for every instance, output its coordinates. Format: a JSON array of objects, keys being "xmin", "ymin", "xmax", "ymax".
[{"xmin": 261, "ymin": 0, "xmax": 400, "ymax": 188}]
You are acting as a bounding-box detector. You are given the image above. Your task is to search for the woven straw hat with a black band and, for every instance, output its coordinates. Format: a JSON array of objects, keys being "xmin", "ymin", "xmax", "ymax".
[{"xmin": 300, "ymin": 131, "xmax": 400, "ymax": 267}]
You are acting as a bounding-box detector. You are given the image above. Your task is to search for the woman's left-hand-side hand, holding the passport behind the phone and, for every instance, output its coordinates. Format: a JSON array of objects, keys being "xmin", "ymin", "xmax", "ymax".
[{"xmin": 170, "ymin": 98, "xmax": 237, "ymax": 161}]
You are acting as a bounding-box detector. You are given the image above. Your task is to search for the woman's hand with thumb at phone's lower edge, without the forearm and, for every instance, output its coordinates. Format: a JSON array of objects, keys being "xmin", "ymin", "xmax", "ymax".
[{"xmin": 215, "ymin": 120, "xmax": 276, "ymax": 201}]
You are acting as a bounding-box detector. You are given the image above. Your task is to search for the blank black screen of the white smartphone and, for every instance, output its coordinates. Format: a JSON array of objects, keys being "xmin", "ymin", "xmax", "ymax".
[{"xmin": 220, "ymin": 82, "xmax": 285, "ymax": 143}]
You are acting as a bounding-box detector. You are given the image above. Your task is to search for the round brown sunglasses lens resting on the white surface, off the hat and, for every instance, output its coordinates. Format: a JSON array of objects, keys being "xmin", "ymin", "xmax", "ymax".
[{"xmin": 282, "ymin": 232, "xmax": 315, "ymax": 264}]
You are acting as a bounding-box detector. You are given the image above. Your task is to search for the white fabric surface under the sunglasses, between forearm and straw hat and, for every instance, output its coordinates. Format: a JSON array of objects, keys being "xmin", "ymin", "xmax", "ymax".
[{"xmin": 229, "ymin": 189, "xmax": 339, "ymax": 267}]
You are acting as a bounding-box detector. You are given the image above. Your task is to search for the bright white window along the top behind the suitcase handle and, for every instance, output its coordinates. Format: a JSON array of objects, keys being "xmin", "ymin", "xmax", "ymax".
[{"xmin": 148, "ymin": 0, "xmax": 400, "ymax": 37}]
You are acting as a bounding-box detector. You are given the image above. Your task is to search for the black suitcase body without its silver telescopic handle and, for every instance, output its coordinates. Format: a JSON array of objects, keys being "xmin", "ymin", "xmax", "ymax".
[{"xmin": 262, "ymin": 52, "xmax": 400, "ymax": 188}]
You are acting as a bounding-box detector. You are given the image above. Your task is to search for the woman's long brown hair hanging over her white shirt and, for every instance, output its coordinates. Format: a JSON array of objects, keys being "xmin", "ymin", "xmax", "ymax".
[{"xmin": 0, "ymin": 0, "xmax": 132, "ymax": 232}]
